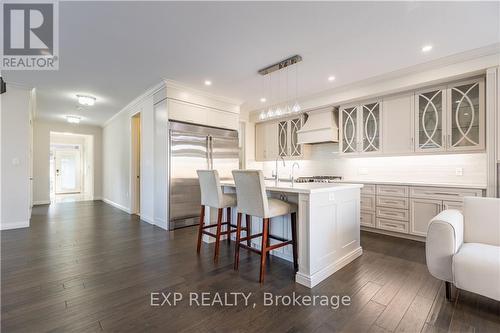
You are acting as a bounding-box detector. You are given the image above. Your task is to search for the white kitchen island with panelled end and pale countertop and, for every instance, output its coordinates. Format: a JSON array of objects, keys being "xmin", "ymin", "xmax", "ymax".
[{"xmin": 222, "ymin": 181, "xmax": 363, "ymax": 288}]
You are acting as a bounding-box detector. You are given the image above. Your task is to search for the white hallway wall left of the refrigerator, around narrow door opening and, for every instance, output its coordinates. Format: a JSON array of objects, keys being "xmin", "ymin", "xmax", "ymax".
[{"xmin": 103, "ymin": 96, "xmax": 154, "ymax": 223}]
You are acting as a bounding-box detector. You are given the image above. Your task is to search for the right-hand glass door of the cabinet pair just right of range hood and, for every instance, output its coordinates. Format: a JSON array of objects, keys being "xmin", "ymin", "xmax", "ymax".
[{"xmin": 361, "ymin": 103, "xmax": 380, "ymax": 152}]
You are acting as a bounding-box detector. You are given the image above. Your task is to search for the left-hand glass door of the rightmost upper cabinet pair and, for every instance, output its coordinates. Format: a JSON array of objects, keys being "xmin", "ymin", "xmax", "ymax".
[{"xmin": 415, "ymin": 89, "xmax": 444, "ymax": 150}]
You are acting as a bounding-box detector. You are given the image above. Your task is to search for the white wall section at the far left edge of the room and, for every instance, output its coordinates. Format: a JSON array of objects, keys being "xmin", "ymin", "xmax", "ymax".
[{"xmin": 0, "ymin": 85, "xmax": 31, "ymax": 230}]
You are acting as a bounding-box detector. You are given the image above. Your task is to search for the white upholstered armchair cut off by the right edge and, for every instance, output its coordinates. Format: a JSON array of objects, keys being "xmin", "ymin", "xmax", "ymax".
[{"xmin": 425, "ymin": 197, "xmax": 500, "ymax": 301}]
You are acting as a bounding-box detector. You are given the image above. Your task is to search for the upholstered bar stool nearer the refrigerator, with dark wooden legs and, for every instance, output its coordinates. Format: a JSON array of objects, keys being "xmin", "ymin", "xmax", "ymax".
[{"xmin": 196, "ymin": 170, "xmax": 242, "ymax": 262}]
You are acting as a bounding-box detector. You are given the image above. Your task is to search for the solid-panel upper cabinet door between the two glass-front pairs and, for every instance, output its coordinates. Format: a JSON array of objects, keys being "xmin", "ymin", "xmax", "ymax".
[{"xmin": 382, "ymin": 93, "xmax": 414, "ymax": 154}]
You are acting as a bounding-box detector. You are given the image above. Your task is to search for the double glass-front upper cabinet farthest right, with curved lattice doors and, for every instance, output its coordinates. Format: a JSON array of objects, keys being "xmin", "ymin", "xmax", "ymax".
[{"xmin": 415, "ymin": 78, "xmax": 485, "ymax": 152}]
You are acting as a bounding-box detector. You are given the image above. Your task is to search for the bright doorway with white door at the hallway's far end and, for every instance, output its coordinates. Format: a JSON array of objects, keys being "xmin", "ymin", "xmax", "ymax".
[{"xmin": 49, "ymin": 132, "xmax": 94, "ymax": 203}]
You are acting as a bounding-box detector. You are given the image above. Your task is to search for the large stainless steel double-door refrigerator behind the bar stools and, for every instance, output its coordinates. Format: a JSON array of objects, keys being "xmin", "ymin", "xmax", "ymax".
[{"xmin": 168, "ymin": 121, "xmax": 239, "ymax": 230}]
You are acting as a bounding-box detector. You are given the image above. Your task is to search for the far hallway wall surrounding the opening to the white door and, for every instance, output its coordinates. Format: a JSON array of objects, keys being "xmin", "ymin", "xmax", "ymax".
[{"xmin": 33, "ymin": 120, "xmax": 103, "ymax": 204}]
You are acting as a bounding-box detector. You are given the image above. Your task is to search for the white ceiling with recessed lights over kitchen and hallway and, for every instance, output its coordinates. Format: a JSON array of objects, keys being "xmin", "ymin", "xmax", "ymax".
[{"xmin": 3, "ymin": 2, "xmax": 500, "ymax": 125}]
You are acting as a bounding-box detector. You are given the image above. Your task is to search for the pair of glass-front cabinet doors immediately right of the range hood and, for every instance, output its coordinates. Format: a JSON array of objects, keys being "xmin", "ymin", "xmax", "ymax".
[{"xmin": 340, "ymin": 101, "xmax": 382, "ymax": 154}]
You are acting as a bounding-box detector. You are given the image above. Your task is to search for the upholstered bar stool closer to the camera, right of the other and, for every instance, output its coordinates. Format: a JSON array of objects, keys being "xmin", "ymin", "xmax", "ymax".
[{"xmin": 233, "ymin": 170, "xmax": 298, "ymax": 283}]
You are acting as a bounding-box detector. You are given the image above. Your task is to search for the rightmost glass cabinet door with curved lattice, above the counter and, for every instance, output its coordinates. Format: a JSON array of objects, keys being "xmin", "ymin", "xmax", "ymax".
[{"xmin": 448, "ymin": 82, "xmax": 484, "ymax": 150}]
